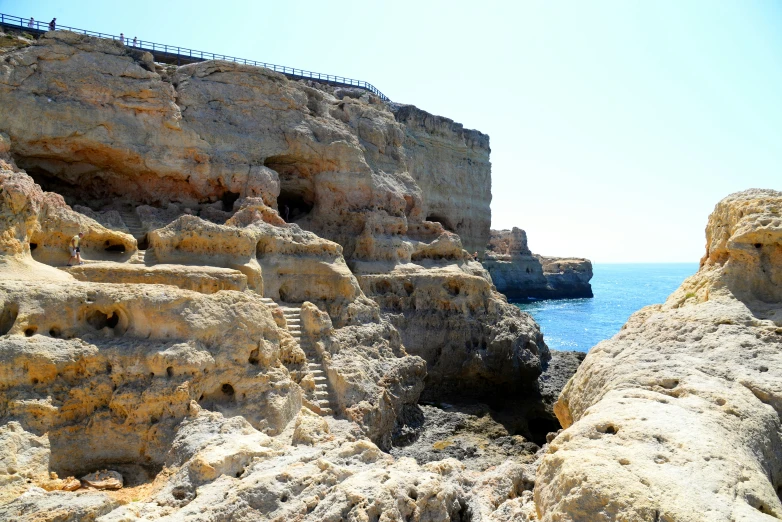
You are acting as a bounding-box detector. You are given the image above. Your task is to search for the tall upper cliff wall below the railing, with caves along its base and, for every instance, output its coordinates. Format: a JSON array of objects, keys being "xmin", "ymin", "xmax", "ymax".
[{"xmin": 0, "ymin": 31, "xmax": 491, "ymax": 257}]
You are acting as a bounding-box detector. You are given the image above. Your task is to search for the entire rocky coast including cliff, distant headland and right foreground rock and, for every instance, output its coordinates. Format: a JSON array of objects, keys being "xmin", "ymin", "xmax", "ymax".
[{"xmin": 0, "ymin": 27, "xmax": 782, "ymax": 522}]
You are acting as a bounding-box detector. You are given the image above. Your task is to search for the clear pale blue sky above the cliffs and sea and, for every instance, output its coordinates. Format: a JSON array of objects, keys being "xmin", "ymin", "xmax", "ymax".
[{"xmin": 6, "ymin": 0, "xmax": 782, "ymax": 262}]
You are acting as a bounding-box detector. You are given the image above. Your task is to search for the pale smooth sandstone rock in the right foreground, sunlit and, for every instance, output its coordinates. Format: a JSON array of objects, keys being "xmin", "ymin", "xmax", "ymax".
[{"xmin": 535, "ymin": 190, "xmax": 782, "ymax": 521}]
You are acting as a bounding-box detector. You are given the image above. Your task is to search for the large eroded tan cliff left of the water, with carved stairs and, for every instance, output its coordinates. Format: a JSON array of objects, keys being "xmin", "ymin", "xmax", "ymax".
[{"xmin": 0, "ymin": 31, "xmax": 549, "ymax": 521}]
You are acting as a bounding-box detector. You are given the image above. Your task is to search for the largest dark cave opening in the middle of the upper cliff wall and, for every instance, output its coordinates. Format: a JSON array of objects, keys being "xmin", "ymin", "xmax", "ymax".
[{"xmin": 264, "ymin": 156, "xmax": 315, "ymax": 223}]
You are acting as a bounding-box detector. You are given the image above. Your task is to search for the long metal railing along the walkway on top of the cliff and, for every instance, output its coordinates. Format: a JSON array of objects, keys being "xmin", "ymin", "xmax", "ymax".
[{"xmin": 0, "ymin": 13, "xmax": 389, "ymax": 101}]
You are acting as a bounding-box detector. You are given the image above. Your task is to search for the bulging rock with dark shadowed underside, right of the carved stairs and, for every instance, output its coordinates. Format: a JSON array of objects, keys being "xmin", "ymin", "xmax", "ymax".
[{"xmin": 359, "ymin": 263, "xmax": 549, "ymax": 400}]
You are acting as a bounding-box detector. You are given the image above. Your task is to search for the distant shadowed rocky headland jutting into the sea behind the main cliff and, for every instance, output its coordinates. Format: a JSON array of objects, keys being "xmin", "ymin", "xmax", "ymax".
[{"xmin": 482, "ymin": 227, "xmax": 592, "ymax": 299}]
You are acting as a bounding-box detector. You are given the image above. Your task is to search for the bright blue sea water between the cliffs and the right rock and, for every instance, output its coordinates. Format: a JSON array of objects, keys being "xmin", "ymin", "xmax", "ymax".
[{"xmin": 514, "ymin": 263, "xmax": 698, "ymax": 352}]
